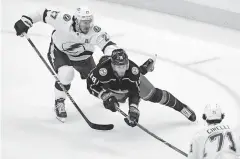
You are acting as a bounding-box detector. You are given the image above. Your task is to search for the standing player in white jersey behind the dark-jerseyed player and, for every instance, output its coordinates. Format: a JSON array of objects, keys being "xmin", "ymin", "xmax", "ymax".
[{"xmin": 14, "ymin": 7, "xmax": 115, "ymax": 121}]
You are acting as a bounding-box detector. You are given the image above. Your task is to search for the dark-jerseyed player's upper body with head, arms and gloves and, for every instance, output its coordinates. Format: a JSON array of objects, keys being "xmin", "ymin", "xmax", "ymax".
[{"xmin": 87, "ymin": 49, "xmax": 140, "ymax": 127}]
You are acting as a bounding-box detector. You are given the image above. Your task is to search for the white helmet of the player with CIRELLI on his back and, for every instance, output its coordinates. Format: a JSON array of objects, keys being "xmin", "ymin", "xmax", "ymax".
[{"xmin": 203, "ymin": 104, "xmax": 224, "ymax": 121}]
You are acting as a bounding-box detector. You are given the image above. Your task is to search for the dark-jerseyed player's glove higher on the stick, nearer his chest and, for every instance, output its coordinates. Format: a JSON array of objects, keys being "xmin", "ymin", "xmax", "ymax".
[{"xmin": 101, "ymin": 92, "xmax": 119, "ymax": 112}]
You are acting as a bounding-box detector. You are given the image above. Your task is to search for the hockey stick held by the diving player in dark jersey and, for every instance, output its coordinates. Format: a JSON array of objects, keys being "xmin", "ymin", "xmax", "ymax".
[{"xmin": 115, "ymin": 105, "xmax": 188, "ymax": 157}]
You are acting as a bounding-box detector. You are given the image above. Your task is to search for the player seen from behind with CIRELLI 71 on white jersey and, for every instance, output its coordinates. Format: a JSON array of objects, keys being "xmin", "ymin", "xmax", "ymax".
[{"xmin": 188, "ymin": 104, "xmax": 240, "ymax": 159}]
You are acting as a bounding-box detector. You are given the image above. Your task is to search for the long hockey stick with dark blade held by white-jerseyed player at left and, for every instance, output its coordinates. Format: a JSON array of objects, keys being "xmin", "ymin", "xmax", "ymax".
[{"xmin": 23, "ymin": 33, "xmax": 114, "ymax": 130}]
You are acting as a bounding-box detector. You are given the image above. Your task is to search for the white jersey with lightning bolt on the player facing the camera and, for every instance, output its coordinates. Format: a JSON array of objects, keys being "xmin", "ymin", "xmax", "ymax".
[{"xmin": 26, "ymin": 9, "xmax": 114, "ymax": 61}]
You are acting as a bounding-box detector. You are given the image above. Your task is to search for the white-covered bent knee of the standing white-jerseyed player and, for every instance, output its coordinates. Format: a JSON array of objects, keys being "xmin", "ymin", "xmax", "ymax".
[{"xmin": 58, "ymin": 66, "xmax": 74, "ymax": 85}]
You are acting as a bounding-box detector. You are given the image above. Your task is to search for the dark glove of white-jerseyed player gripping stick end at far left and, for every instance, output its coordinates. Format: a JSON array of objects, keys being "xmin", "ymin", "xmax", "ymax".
[{"xmin": 14, "ymin": 16, "xmax": 33, "ymax": 36}]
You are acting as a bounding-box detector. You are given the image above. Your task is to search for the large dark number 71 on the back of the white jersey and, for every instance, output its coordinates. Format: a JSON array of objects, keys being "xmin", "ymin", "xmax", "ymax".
[{"xmin": 210, "ymin": 132, "xmax": 236, "ymax": 152}]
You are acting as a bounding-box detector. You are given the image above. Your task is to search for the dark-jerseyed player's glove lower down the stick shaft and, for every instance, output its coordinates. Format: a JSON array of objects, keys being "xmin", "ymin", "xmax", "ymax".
[{"xmin": 124, "ymin": 106, "xmax": 140, "ymax": 127}]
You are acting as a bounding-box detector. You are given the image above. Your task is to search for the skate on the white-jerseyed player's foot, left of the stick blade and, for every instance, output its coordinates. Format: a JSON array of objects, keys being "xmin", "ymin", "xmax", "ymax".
[{"xmin": 55, "ymin": 98, "xmax": 67, "ymax": 123}]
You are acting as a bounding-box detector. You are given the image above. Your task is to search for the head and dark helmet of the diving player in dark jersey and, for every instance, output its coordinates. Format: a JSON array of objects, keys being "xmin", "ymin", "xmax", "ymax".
[{"xmin": 111, "ymin": 49, "xmax": 129, "ymax": 77}]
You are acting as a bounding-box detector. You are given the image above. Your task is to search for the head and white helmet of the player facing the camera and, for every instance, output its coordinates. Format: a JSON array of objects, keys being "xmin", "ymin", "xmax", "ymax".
[{"xmin": 73, "ymin": 7, "xmax": 93, "ymax": 34}]
